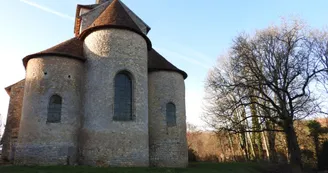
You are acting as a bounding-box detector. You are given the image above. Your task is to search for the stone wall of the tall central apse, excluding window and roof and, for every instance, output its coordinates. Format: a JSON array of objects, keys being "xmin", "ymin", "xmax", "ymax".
[{"xmin": 81, "ymin": 29, "xmax": 149, "ymax": 166}]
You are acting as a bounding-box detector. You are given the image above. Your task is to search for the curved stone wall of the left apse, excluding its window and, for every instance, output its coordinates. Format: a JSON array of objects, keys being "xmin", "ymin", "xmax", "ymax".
[{"xmin": 15, "ymin": 56, "xmax": 83, "ymax": 165}]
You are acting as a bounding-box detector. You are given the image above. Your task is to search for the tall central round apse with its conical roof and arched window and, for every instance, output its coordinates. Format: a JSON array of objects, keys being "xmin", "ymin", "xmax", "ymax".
[{"xmin": 79, "ymin": 0, "xmax": 151, "ymax": 166}]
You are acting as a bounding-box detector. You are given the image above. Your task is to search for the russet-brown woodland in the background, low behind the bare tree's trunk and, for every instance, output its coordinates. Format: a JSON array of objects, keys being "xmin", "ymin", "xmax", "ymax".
[{"xmin": 187, "ymin": 118, "xmax": 328, "ymax": 168}]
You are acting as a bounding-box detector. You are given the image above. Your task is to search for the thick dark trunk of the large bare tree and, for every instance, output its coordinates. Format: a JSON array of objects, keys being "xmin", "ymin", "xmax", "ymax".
[{"xmin": 284, "ymin": 120, "xmax": 302, "ymax": 173}]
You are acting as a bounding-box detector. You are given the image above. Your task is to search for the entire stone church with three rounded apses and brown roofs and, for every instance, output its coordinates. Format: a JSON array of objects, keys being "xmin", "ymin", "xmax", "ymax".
[{"xmin": 2, "ymin": 0, "xmax": 188, "ymax": 167}]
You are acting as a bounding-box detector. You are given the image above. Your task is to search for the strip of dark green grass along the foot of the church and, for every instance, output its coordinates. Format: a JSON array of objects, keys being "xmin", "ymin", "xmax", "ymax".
[{"xmin": 0, "ymin": 163, "xmax": 266, "ymax": 173}]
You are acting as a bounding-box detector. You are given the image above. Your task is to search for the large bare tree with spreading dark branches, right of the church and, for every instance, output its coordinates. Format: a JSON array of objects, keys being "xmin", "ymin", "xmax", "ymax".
[{"xmin": 206, "ymin": 21, "xmax": 327, "ymax": 172}]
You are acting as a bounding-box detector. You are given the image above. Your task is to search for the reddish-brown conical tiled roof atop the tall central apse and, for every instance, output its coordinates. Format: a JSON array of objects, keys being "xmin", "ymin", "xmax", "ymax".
[{"xmin": 80, "ymin": 0, "xmax": 151, "ymax": 49}]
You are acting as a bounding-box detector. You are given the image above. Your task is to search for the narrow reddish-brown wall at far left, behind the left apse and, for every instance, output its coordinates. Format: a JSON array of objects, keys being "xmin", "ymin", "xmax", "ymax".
[{"xmin": 1, "ymin": 80, "xmax": 25, "ymax": 161}]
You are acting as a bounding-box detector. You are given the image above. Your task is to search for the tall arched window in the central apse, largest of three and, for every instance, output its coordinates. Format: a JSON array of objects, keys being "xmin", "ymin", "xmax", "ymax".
[{"xmin": 114, "ymin": 72, "xmax": 132, "ymax": 121}]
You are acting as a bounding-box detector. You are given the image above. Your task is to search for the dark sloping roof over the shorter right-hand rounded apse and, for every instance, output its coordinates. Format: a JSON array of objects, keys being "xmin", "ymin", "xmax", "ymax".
[{"xmin": 148, "ymin": 49, "xmax": 188, "ymax": 79}]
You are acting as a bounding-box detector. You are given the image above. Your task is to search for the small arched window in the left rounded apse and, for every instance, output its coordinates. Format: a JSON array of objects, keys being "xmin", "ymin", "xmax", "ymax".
[{"xmin": 47, "ymin": 95, "xmax": 62, "ymax": 123}]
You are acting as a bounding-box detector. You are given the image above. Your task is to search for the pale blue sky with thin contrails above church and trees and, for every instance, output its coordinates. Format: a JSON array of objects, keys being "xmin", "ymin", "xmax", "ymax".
[{"xmin": 0, "ymin": 0, "xmax": 328, "ymax": 133}]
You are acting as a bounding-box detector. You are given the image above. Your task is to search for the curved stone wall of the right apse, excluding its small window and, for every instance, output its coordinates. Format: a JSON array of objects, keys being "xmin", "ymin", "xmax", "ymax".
[{"xmin": 148, "ymin": 71, "xmax": 188, "ymax": 167}]
